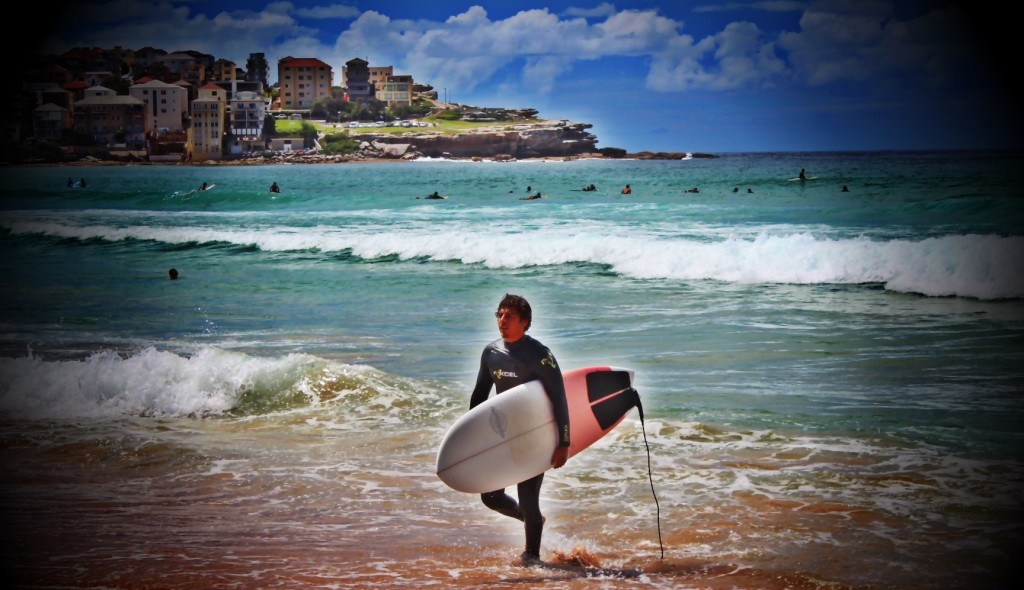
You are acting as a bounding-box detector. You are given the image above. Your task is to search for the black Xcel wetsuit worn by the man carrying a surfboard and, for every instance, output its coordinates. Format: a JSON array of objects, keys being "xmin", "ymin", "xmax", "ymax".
[{"xmin": 469, "ymin": 336, "xmax": 569, "ymax": 558}]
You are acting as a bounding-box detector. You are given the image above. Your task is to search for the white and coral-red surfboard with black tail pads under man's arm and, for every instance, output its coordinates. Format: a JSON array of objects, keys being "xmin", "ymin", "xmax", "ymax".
[{"xmin": 437, "ymin": 367, "xmax": 639, "ymax": 494}]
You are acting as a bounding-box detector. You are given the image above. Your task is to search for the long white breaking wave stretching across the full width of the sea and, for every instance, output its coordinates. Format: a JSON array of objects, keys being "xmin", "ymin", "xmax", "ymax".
[{"xmin": 4, "ymin": 211, "xmax": 1024, "ymax": 299}]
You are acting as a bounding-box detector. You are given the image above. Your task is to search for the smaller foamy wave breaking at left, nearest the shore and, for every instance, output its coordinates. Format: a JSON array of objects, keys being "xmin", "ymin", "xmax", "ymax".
[{"xmin": 0, "ymin": 347, "xmax": 460, "ymax": 429}]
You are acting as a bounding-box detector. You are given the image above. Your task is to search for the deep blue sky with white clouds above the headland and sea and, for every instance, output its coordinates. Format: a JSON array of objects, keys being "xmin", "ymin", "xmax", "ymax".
[{"xmin": 28, "ymin": 0, "xmax": 1024, "ymax": 153}]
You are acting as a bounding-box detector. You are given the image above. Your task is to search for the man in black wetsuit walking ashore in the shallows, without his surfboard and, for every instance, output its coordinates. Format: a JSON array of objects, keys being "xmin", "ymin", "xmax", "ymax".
[{"xmin": 469, "ymin": 293, "xmax": 569, "ymax": 564}]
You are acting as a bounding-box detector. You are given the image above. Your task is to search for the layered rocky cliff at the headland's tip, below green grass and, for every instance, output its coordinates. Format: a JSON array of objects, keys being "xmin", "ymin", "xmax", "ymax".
[{"xmin": 353, "ymin": 121, "xmax": 597, "ymax": 159}]
